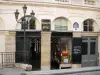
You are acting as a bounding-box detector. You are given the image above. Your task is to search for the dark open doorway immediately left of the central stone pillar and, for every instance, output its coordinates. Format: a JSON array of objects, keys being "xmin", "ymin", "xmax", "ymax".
[{"xmin": 29, "ymin": 38, "xmax": 41, "ymax": 70}]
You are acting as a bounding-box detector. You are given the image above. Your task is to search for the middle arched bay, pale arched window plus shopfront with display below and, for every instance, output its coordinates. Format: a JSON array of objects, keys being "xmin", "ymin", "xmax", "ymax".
[{"xmin": 51, "ymin": 17, "xmax": 72, "ymax": 69}]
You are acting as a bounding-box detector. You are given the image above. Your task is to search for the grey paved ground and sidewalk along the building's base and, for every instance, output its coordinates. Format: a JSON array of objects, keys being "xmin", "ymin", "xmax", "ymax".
[{"xmin": 0, "ymin": 66, "xmax": 100, "ymax": 75}]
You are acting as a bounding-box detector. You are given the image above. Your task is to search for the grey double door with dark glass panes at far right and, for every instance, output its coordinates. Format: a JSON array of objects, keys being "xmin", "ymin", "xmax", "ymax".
[{"xmin": 82, "ymin": 37, "xmax": 98, "ymax": 67}]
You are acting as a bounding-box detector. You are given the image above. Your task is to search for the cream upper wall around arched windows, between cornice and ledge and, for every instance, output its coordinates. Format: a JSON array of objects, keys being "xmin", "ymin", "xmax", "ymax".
[{"xmin": 0, "ymin": 5, "xmax": 100, "ymax": 31}]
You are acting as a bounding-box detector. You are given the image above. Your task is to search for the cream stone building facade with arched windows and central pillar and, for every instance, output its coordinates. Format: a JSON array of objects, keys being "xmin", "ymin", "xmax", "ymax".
[{"xmin": 0, "ymin": 0, "xmax": 100, "ymax": 70}]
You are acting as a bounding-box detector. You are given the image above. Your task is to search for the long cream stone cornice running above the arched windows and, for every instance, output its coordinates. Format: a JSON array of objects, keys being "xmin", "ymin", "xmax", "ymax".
[{"xmin": 0, "ymin": 1, "xmax": 100, "ymax": 11}]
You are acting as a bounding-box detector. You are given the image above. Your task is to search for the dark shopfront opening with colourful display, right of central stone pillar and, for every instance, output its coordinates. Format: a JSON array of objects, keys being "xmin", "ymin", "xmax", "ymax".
[{"xmin": 51, "ymin": 32, "xmax": 72, "ymax": 69}]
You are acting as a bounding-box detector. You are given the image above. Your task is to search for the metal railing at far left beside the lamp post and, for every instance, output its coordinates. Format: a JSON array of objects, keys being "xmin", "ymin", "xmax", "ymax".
[{"xmin": 0, "ymin": 52, "xmax": 28, "ymax": 67}]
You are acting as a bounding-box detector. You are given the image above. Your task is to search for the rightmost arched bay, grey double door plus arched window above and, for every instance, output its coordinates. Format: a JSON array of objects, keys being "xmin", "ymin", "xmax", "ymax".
[{"xmin": 82, "ymin": 19, "xmax": 98, "ymax": 67}]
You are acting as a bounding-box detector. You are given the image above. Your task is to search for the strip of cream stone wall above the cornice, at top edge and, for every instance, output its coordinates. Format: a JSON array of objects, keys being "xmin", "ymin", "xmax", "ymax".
[{"xmin": 0, "ymin": 0, "xmax": 100, "ymax": 7}]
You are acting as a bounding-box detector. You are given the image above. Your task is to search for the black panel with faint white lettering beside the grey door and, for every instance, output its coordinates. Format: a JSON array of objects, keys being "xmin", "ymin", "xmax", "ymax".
[{"xmin": 72, "ymin": 37, "xmax": 82, "ymax": 64}]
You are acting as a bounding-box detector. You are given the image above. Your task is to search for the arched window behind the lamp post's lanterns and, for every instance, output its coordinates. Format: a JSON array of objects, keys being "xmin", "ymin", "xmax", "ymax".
[{"xmin": 16, "ymin": 15, "xmax": 41, "ymax": 30}]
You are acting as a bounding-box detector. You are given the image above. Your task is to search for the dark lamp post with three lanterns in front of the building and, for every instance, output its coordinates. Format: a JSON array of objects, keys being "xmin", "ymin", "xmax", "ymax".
[{"xmin": 15, "ymin": 5, "xmax": 35, "ymax": 63}]
